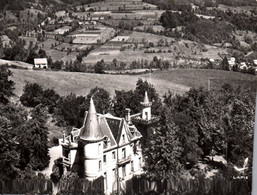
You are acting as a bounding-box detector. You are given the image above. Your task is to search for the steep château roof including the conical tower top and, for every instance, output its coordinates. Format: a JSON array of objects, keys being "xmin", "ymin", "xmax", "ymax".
[{"xmin": 68, "ymin": 98, "xmax": 142, "ymax": 146}]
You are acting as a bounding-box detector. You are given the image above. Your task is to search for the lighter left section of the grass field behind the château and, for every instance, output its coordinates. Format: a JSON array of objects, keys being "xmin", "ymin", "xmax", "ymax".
[{"xmin": 11, "ymin": 69, "xmax": 189, "ymax": 96}]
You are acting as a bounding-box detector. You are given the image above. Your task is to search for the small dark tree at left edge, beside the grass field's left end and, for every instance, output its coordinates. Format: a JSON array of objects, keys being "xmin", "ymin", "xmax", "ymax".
[{"xmin": 0, "ymin": 66, "xmax": 14, "ymax": 104}]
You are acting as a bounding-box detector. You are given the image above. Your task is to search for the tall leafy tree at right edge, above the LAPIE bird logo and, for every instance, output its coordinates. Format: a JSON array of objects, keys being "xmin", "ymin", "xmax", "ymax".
[{"xmin": 219, "ymin": 85, "xmax": 255, "ymax": 163}]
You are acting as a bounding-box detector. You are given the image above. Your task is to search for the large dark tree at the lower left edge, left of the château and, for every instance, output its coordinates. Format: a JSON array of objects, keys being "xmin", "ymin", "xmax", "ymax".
[{"xmin": 0, "ymin": 103, "xmax": 33, "ymax": 180}]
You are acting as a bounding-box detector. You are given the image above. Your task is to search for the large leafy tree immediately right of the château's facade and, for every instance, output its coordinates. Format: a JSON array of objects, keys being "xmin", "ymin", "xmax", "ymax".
[{"xmin": 145, "ymin": 116, "xmax": 182, "ymax": 179}]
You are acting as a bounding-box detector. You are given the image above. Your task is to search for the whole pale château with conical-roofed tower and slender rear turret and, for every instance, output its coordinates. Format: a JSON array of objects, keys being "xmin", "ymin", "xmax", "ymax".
[{"xmin": 61, "ymin": 93, "xmax": 151, "ymax": 194}]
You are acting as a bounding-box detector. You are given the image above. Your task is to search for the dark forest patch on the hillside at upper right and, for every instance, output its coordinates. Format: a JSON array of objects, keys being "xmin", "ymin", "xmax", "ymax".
[{"xmin": 160, "ymin": 10, "xmax": 257, "ymax": 47}]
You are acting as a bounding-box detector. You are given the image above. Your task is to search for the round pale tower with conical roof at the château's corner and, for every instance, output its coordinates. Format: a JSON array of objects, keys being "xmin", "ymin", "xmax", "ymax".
[{"xmin": 78, "ymin": 98, "xmax": 104, "ymax": 180}]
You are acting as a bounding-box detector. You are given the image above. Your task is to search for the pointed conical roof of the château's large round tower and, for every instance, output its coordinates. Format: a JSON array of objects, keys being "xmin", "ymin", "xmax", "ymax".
[{"xmin": 80, "ymin": 98, "xmax": 104, "ymax": 141}]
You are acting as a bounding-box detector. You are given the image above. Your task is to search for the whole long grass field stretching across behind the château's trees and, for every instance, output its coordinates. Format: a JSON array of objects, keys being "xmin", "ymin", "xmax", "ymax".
[{"xmin": 11, "ymin": 69, "xmax": 257, "ymax": 100}]
